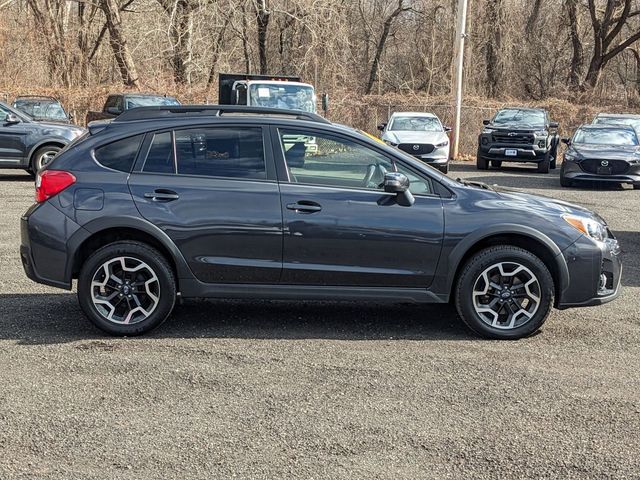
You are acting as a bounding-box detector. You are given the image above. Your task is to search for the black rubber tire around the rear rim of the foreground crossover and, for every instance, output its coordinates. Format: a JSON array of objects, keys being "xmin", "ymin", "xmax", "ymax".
[{"xmin": 78, "ymin": 241, "xmax": 176, "ymax": 336}]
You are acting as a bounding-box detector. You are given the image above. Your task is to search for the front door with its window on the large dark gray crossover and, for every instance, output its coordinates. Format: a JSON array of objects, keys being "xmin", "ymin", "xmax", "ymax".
[{"xmin": 274, "ymin": 125, "xmax": 444, "ymax": 288}]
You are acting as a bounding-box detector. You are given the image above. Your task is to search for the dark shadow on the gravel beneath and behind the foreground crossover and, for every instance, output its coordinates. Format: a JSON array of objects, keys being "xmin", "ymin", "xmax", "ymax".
[{"xmin": 0, "ymin": 294, "xmax": 476, "ymax": 345}]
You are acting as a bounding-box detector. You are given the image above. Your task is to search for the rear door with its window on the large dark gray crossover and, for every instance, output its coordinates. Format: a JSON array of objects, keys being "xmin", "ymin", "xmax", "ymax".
[{"xmin": 129, "ymin": 125, "xmax": 282, "ymax": 284}]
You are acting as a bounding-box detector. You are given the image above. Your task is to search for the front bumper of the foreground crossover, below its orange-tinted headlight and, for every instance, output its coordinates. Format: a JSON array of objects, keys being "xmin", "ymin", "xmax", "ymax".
[{"xmin": 557, "ymin": 232, "xmax": 622, "ymax": 310}]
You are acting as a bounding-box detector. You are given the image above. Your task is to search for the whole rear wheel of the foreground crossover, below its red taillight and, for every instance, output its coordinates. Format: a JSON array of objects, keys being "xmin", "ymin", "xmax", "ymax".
[{"xmin": 78, "ymin": 241, "xmax": 176, "ymax": 336}]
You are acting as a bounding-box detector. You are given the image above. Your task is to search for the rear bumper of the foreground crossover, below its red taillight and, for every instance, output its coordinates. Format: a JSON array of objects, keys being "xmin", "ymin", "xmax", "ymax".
[{"xmin": 20, "ymin": 202, "xmax": 81, "ymax": 290}]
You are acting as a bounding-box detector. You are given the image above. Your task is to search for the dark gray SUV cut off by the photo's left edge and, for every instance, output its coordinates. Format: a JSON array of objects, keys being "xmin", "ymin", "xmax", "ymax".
[{"xmin": 0, "ymin": 102, "xmax": 85, "ymax": 174}]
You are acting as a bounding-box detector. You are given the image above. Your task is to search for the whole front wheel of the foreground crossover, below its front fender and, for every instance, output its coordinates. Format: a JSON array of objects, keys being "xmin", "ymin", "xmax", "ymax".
[{"xmin": 455, "ymin": 245, "xmax": 554, "ymax": 340}]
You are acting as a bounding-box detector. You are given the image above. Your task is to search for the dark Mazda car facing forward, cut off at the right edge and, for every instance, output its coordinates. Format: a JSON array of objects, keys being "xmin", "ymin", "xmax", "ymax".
[{"xmin": 560, "ymin": 125, "xmax": 640, "ymax": 189}]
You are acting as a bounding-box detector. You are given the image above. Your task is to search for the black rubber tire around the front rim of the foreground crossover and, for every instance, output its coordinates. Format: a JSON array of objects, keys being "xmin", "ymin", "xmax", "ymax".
[{"xmin": 455, "ymin": 245, "xmax": 554, "ymax": 340}]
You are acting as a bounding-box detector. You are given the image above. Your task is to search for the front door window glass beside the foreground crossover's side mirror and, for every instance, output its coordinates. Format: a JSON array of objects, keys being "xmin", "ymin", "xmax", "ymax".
[{"xmin": 279, "ymin": 130, "xmax": 394, "ymax": 190}]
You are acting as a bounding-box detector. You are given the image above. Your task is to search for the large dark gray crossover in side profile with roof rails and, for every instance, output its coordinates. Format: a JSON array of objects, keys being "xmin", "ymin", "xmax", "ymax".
[{"xmin": 20, "ymin": 106, "xmax": 621, "ymax": 338}]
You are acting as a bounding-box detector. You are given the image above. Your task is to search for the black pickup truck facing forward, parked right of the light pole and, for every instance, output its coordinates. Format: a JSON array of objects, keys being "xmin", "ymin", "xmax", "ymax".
[{"xmin": 476, "ymin": 108, "xmax": 560, "ymax": 173}]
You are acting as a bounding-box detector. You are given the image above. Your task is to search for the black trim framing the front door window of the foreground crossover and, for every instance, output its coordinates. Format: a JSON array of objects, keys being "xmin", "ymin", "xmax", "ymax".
[{"xmin": 271, "ymin": 125, "xmax": 441, "ymax": 198}]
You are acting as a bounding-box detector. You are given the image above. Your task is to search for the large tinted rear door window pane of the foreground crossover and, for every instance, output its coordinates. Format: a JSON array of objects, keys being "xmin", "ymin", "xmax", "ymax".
[{"xmin": 175, "ymin": 127, "xmax": 267, "ymax": 180}]
